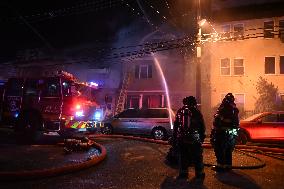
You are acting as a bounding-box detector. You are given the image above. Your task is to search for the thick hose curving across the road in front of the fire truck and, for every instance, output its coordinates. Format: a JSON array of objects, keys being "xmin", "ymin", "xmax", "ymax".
[{"xmin": 0, "ymin": 142, "xmax": 107, "ymax": 181}]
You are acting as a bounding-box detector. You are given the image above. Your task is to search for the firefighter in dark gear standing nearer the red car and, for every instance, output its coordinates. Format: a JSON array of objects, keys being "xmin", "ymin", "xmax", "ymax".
[{"xmin": 211, "ymin": 93, "xmax": 239, "ymax": 172}]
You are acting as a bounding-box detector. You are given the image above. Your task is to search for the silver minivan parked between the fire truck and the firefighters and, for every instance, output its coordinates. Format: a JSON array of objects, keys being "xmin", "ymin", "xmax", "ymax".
[{"xmin": 102, "ymin": 108, "xmax": 174, "ymax": 140}]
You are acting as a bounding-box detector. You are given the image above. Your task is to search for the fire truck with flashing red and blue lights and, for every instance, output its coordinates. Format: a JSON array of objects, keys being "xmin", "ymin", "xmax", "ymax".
[{"xmin": 1, "ymin": 71, "xmax": 103, "ymax": 141}]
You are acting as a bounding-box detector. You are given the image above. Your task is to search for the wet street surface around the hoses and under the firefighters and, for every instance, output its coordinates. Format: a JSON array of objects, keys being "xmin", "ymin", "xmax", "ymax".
[{"xmin": 0, "ymin": 127, "xmax": 284, "ymax": 189}]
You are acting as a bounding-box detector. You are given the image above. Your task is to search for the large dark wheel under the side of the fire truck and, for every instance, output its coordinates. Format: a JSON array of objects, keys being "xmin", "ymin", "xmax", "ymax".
[{"xmin": 15, "ymin": 112, "xmax": 42, "ymax": 143}]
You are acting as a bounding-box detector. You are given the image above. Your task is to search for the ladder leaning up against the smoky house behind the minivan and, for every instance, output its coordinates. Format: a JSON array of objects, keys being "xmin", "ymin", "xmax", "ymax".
[{"xmin": 115, "ymin": 71, "xmax": 131, "ymax": 114}]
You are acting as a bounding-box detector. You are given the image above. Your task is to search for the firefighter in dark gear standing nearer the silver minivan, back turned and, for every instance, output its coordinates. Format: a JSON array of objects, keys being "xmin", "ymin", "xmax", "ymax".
[{"xmin": 173, "ymin": 96, "xmax": 205, "ymax": 181}]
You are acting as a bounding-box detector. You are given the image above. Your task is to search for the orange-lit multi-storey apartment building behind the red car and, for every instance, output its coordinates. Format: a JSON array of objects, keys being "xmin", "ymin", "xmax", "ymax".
[{"xmin": 201, "ymin": 1, "xmax": 284, "ymax": 122}]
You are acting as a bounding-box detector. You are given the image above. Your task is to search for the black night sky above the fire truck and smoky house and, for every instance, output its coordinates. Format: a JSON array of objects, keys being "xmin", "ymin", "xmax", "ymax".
[{"xmin": 0, "ymin": 0, "xmax": 197, "ymax": 62}]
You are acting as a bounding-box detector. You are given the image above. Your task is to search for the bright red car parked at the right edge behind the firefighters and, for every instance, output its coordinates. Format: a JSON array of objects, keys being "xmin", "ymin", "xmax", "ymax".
[{"xmin": 238, "ymin": 111, "xmax": 284, "ymax": 144}]
